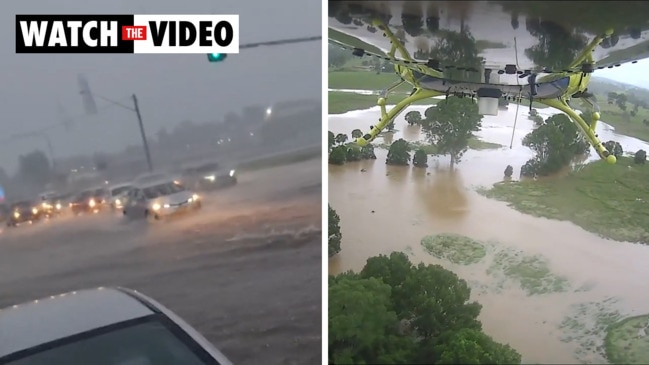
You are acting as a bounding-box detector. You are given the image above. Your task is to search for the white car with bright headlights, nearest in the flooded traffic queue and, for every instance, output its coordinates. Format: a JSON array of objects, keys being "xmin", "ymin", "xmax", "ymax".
[{"xmin": 123, "ymin": 179, "xmax": 202, "ymax": 220}]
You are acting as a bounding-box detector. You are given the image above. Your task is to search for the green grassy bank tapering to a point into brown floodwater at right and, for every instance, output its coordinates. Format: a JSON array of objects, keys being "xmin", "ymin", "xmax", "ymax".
[{"xmin": 480, "ymin": 157, "xmax": 649, "ymax": 244}]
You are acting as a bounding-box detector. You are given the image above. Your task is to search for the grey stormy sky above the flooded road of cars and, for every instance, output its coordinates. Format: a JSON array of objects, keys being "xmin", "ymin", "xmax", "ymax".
[{"xmin": 0, "ymin": 0, "xmax": 322, "ymax": 172}]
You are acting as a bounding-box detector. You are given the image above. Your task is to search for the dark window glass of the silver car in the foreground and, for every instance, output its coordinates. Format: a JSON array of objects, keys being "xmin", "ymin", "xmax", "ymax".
[{"xmin": 8, "ymin": 321, "xmax": 216, "ymax": 365}]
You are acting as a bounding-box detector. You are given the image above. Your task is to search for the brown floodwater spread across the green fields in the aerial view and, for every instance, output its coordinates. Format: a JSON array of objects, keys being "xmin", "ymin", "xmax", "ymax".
[{"xmin": 329, "ymin": 101, "xmax": 649, "ymax": 364}]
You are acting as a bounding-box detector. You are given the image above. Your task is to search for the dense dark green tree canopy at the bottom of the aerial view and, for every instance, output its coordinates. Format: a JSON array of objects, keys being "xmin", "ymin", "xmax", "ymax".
[{"xmin": 329, "ymin": 252, "xmax": 521, "ymax": 364}]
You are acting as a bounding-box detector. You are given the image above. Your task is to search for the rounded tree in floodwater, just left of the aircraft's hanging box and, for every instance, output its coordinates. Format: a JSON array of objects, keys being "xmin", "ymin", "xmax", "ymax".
[{"xmin": 422, "ymin": 97, "xmax": 482, "ymax": 169}]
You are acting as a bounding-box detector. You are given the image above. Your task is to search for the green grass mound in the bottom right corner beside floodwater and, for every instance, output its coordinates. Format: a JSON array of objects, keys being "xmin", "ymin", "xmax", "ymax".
[{"xmin": 604, "ymin": 314, "xmax": 649, "ymax": 364}]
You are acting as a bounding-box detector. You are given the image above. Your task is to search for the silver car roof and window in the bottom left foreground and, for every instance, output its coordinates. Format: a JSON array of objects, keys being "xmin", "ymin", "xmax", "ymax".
[{"xmin": 0, "ymin": 288, "xmax": 232, "ymax": 365}]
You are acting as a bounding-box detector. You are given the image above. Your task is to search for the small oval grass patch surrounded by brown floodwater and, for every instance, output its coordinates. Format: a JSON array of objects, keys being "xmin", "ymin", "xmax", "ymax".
[{"xmin": 421, "ymin": 234, "xmax": 487, "ymax": 265}]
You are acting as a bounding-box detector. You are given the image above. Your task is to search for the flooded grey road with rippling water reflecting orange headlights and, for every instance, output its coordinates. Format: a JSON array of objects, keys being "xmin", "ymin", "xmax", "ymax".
[{"xmin": 0, "ymin": 159, "xmax": 321, "ymax": 364}]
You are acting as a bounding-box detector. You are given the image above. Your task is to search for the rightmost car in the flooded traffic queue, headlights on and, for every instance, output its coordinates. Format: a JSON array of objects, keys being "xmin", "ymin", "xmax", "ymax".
[{"xmin": 181, "ymin": 162, "xmax": 237, "ymax": 191}]
